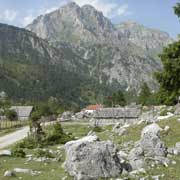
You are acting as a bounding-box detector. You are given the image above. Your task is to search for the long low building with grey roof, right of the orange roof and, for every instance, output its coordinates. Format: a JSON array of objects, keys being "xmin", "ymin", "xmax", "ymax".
[{"xmin": 91, "ymin": 107, "xmax": 141, "ymax": 125}]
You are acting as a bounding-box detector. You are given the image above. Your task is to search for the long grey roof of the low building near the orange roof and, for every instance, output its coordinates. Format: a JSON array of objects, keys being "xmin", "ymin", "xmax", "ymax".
[{"xmin": 94, "ymin": 107, "xmax": 141, "ymax": 118}]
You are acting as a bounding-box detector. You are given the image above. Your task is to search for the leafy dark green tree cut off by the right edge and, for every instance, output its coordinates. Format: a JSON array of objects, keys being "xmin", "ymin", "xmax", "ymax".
[{"xmin": 156, "ymin": 3, "xmax": 180, "ymax": 105}]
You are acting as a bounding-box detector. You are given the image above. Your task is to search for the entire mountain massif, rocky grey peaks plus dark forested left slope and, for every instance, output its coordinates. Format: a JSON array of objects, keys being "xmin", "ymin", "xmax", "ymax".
[{"xmin": 0, "ymin": 3, "xmax": 172, "ymax": 104}]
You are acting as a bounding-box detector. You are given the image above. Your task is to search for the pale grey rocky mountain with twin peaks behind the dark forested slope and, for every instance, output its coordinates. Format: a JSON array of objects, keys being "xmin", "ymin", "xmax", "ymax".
[{"xmin": 26, "ymin": 3, "xmax": 172, "ymax": 91}]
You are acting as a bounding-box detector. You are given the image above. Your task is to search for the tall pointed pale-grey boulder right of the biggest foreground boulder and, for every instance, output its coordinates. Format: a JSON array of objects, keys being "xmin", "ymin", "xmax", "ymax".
[{"xmin": 128, "ymin": 123, "xmax": 168, "ymax": 169}]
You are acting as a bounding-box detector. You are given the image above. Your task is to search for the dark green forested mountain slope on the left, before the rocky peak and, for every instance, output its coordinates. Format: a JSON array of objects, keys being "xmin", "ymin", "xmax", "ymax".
[{"xmin": 0, "ymin": 24, "xmax": 111, "ymax": 105}]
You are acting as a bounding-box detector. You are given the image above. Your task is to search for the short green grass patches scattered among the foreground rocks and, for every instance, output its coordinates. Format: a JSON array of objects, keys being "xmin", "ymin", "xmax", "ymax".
[{"xmin": 0, "ymin": 117, "xmax": 180, "ymax": 180}]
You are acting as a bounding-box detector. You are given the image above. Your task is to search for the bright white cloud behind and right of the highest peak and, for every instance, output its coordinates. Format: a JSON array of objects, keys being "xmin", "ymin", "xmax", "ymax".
[{"xmin": 73, "ymin": 0, "xmax": 132, "ymax": 18}]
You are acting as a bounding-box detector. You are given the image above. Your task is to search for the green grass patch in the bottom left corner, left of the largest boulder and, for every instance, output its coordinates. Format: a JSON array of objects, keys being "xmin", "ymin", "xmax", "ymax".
[{"xmin": 0, "ymin": 157, "xmax": 72, "ymax": 180}]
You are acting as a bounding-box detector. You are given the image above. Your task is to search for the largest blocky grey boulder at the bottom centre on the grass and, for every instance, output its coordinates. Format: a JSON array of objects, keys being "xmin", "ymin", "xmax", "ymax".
[{"xmin": 65, "ymin": 135, "xmax": 122, "ymax": 180}]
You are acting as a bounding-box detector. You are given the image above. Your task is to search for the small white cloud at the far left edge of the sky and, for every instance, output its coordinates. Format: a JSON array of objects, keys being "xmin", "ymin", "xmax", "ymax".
[{"xmin": 0, "ymin": 9, "xmax": 17, "ymax": 22}]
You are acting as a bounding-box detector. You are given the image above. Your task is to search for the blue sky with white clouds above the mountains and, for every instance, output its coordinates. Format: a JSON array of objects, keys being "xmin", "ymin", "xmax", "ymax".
[{"xmin": 0, "ymin": 0, "xmax": 180, "ymax": 38}]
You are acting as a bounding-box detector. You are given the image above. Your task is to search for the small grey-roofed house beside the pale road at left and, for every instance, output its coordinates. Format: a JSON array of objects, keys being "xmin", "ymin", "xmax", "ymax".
[{"xmin": 10, "ymin": 106, "xmax": 33, "ymax": 121}]
